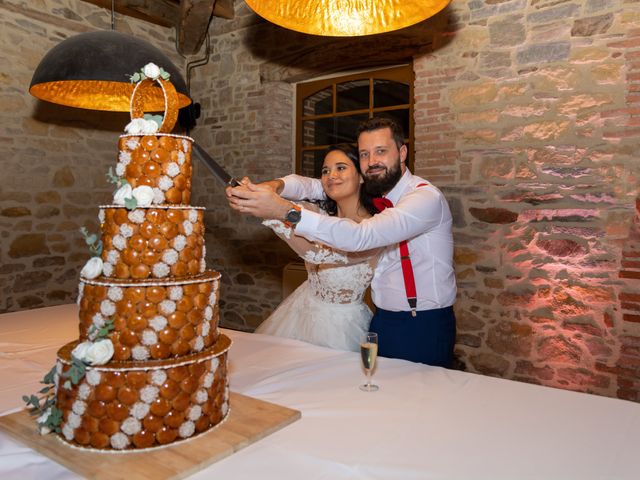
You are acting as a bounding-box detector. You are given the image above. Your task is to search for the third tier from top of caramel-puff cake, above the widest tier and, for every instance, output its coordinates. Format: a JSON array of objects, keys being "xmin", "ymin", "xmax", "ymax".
[{"xmin": 78, "ymin": 270, "xmax": 220, "ymax": 361}]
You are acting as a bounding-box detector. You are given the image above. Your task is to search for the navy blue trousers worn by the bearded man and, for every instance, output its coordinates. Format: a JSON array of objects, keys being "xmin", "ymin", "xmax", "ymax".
[{"xmin": 369, "ymin": 307, "xmax": 456, "ymax": 368}]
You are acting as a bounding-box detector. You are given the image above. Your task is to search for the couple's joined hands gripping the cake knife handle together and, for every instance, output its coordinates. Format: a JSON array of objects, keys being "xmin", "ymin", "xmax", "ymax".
[{"xmin": 226, "ymin": 177, "xmax": 291, "ymax": 220}]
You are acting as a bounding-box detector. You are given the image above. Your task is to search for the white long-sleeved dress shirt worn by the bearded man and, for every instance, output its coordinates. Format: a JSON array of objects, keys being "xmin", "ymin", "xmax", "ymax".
[{"xmin": 282, "ymin": 170, "xmax": 456, "ymax": 312}]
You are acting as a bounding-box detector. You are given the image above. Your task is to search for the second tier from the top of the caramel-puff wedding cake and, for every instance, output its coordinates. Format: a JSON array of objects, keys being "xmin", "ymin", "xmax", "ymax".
[{"xmin": 98, "ymin": 205, "xmax": 205, "ymax": 279}]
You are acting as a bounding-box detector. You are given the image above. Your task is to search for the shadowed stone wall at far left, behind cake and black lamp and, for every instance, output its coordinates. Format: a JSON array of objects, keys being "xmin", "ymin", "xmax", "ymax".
[{"xmin": 0, "ymin": 0, "xmax": 183, "ymax": 312}]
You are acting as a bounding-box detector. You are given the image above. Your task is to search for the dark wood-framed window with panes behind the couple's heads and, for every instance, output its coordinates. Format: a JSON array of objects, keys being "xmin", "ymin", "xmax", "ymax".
[{"xmin": 296, "ymin": 65, "xmax": 414, "ymax": 177}]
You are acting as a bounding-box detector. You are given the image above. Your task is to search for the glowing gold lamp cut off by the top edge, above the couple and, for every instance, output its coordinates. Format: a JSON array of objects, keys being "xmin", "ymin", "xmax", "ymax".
[{"xmin": 245, "ymin": 0, "xmax": 451, "ymax": 37}]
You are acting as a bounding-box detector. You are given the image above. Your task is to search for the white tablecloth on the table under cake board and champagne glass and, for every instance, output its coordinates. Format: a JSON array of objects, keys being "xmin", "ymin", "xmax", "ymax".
[{"xmin": 0, "ymin": 305, "xmax": 640, "ymax": 480}]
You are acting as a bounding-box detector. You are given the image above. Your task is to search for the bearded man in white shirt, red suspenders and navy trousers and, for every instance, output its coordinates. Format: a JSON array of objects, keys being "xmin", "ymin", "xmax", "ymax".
[{"xmin": 227, "ymin": 118, "xmax": 456, "ymax": 367}]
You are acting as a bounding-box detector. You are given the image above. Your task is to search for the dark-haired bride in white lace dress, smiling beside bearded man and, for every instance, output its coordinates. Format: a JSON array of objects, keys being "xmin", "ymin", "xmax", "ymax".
[{"xmin": 256, "ymin": 144, "xmax": 380, "ymax": 351}]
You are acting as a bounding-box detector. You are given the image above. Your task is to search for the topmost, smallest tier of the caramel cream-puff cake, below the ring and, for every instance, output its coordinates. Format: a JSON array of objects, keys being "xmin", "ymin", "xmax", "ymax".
[{"xmin": 116, "ymin": 133, "xmax": 193, "ymax": 205}]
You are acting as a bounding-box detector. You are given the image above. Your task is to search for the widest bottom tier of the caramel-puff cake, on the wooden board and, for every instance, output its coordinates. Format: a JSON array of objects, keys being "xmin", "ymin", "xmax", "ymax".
[{"xmin": 56, "ymin": 335, "xmax": 231, "ymax": 452}]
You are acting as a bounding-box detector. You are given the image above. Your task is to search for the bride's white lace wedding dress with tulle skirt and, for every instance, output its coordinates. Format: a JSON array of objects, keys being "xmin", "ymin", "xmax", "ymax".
[{"xmin": 256, "ymin": 204, "xmax": 379, "ymax": 351}]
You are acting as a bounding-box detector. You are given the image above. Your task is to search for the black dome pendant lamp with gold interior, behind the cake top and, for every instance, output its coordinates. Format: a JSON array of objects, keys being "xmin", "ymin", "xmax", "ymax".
[{"xmin": 29, "ymin": 31, "xmax": 191, "ymax": 112}]
